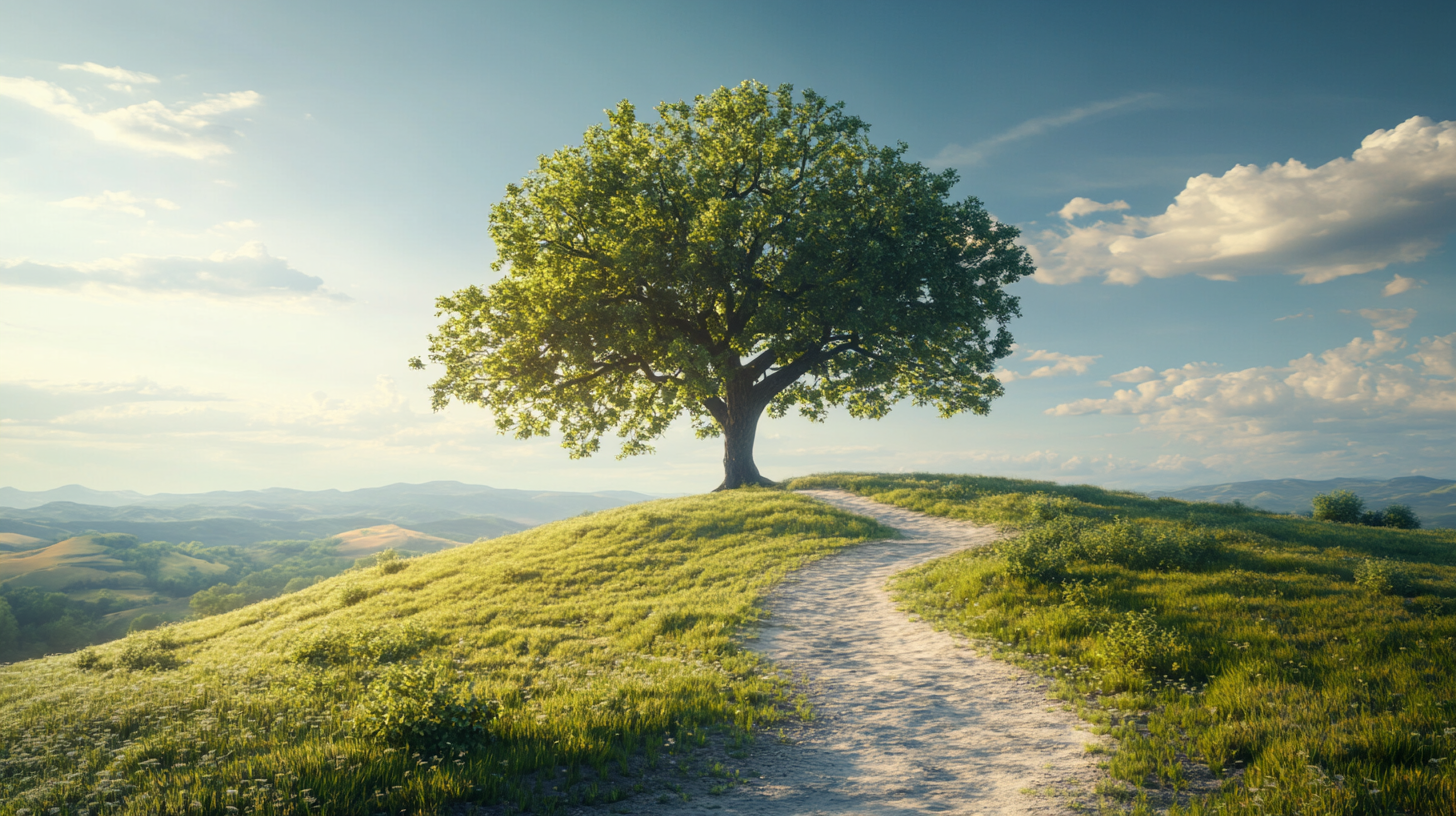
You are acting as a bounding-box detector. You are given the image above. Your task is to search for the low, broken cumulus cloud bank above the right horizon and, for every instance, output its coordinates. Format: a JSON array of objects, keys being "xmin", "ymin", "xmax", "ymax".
[{"xmin": 1047, "ymin": 329, "xmax": 1456, "ymax": 468}]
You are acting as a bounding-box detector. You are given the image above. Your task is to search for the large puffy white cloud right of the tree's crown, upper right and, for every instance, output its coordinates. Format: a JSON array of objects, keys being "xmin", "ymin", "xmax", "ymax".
[{"xmin": 1031, "ymin": 117, "xmax": 1456, "ymax": 284}]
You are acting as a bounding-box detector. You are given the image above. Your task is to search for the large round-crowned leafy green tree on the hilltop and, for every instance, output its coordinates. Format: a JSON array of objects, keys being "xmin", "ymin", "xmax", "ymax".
[{"xmin": 411, "ymin": 82, "xmax": 1034, "ymax": 490}]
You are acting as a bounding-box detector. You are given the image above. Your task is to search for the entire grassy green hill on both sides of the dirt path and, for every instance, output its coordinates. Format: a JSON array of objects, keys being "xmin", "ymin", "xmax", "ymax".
[{"xmin": 0, "ymin": 474, "xmax": 1456, "ymax": 816}]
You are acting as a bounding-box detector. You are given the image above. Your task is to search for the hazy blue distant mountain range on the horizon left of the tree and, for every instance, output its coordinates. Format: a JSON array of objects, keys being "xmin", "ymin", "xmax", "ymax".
[{"xmin": 0, "ymin": 481, "xmax": 654, "ymax": 545}]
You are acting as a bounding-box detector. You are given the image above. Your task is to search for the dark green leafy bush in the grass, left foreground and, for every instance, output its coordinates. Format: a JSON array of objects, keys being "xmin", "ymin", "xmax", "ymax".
[{"xmin": 354, "ymin": 663, "xmax": 499, "ymax": 750}]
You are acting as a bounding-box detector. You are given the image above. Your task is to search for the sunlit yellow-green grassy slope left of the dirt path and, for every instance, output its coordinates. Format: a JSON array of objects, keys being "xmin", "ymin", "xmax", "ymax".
[{"xmin": 0, "ymin": 491, "xmax": 888, "ymax": 815}]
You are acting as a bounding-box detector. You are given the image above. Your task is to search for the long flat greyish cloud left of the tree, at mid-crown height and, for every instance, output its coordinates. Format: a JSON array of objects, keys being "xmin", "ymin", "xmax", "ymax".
[{"xmin": 0, "ymin": 242, "xmax": 349, "ymax": 302}]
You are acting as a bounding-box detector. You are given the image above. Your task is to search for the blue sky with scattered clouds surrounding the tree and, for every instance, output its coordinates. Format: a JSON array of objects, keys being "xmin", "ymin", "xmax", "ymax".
[{"xmin": 0, "ymin": 0, "xmax": 1456, "ymax": 493}]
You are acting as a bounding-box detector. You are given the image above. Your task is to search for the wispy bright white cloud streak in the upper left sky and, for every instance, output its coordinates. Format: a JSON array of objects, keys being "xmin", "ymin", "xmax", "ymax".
[{"xmin": 0, "ymin": 75, "xmax": 262, "ymax": 159}]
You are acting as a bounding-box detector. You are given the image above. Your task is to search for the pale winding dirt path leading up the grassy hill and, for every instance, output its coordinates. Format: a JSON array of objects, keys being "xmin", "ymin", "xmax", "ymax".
[{"xmin": 722, "ymin": 491, "xmax": 1099, "ymax": 816}]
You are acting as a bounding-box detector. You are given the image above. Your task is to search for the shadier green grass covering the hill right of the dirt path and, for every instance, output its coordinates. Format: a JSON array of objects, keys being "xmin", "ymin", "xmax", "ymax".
[{"xmin": 789, "ymin": 474, "xmax": 1456, "ymax": 815}]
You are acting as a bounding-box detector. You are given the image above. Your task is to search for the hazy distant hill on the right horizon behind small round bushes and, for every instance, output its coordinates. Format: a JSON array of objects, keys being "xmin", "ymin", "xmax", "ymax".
[{"xmin": 1149, "ymin": 476, "xmax": 1456, "ymax": 527}]
